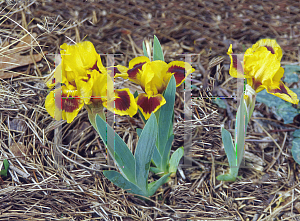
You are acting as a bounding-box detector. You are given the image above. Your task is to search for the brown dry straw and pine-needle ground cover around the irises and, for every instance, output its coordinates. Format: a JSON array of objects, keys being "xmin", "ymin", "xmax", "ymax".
[{"xmin": 0, "ymin": 1, "xmax": 300, "ymax": 220}]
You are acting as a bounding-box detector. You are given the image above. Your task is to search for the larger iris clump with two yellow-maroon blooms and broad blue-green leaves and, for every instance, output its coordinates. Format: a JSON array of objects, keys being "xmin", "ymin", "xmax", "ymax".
[{"xmin": 45, "ymin": 37, "xmax": 194, "ymax": 197}]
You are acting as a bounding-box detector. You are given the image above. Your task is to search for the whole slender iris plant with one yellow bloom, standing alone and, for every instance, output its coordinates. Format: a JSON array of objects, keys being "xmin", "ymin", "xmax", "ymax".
[{"xmin": 217, "ymin": 39, "xmax": 299, "ymax": 181}]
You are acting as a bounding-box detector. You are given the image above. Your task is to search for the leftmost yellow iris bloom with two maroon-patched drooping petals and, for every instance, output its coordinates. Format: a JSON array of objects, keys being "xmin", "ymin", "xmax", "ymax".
[{"xmin": 45, "ymin": 41, "xmax": 137, "ymax": 123}]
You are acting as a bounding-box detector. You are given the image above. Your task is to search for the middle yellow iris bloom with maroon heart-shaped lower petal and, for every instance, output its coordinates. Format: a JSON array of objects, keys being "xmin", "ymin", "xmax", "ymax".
[{"xmin": 115, "ymin": 56, "xmax": 195, "ymax": 119}]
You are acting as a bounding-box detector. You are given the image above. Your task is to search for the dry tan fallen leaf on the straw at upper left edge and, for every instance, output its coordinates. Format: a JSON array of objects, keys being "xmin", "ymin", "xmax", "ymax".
[{"xmin": 0, "ymin": 35, "xmax": 47, "ymax": 79}]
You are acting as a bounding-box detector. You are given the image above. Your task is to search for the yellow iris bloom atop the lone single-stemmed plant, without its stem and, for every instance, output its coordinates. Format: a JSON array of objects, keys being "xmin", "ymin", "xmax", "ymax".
[{"xmin": 227, "ymin": 39, "xmax": 299, "ymax": 104}]
